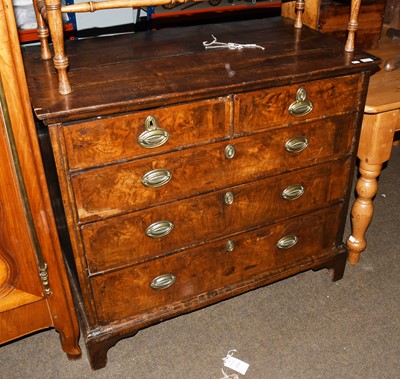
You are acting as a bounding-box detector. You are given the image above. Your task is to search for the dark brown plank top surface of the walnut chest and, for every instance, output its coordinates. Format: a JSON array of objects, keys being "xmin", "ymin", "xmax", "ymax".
[{"xmin": 24, "ymin": 17, "xmax": 379, "ymax": 124}]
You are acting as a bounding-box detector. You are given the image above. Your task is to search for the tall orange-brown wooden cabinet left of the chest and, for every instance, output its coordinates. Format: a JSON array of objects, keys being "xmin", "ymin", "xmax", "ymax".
[{"xmin": 0, "ymin": 0, "xmax": 81, "ymax": 358}]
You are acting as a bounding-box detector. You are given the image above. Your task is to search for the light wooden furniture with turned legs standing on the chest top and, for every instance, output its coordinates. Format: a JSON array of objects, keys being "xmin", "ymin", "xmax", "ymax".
[{"xmin": 33, "ymin": 0, "xmax": 361, "ymax": 95}]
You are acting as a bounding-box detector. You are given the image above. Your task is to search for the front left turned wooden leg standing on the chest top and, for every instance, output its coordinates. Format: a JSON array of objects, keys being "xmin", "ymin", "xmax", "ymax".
[{"xmin": 45, "ymin": 0, "xmax": 71, "ymax": 95}]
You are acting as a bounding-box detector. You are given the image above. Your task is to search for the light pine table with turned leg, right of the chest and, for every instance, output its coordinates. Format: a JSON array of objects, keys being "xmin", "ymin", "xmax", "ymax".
[{"xmin": 347, "ymin": 29, "xmax": 400, "ymax": 264}]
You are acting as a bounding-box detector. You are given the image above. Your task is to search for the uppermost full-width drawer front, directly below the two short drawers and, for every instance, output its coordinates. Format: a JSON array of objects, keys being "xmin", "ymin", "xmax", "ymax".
[{"xmin": 72, "ymin": 115, "xmax": 354, "ymax": 222}]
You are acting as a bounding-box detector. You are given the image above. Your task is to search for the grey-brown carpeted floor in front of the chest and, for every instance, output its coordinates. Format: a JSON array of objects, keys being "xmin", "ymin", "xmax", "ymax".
[{"xmin": 0, "ymin": 147, "xmax": 400, "ymax": 379}]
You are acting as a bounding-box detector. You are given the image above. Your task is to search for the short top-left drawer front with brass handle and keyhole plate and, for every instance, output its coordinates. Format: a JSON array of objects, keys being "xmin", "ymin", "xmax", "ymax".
[{"xmin": 63, "ymin": 98, "xmax": 231, "ymax": 170}]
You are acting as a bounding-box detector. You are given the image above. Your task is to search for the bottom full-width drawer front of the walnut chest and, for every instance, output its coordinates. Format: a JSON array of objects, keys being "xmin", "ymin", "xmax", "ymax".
[{"xmin": 90, "ymin": 206, "xmax": 341, "ymax": 323}]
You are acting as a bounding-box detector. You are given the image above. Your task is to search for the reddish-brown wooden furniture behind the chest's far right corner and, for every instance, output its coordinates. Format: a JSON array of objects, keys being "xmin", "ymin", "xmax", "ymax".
[{"xmin": 282, "ymin": 0, "xmax": 385, "ymax": 50}]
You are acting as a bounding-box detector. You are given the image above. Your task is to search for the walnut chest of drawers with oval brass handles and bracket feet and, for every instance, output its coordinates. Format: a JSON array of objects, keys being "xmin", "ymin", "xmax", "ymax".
[{"xmin": 24, "ymin": 18, "xmax": 379, "ymax": 368}]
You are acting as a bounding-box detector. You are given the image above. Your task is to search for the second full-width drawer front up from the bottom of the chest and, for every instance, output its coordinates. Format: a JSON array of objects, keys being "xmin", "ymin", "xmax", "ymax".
[{"xmin": 82, "ymin": 160, "xmax": 350, "ymax": 273}]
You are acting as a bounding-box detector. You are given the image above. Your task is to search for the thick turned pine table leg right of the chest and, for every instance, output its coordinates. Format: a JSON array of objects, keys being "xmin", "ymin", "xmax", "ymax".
[{"xmin": 347, "ymin": 110, "xmax": 400, "ymax": 265}]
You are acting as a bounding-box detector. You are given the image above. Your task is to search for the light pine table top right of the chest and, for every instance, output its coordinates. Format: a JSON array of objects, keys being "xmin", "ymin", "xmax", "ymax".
[{"xmin": 365, "ymin": 31, "xmax": 400, "ymax": 113}]
